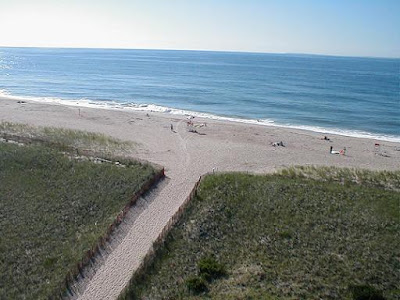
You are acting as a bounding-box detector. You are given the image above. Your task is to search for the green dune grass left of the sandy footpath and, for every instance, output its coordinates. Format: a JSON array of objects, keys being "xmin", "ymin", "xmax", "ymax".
[{"xmin": 0, "ymin": 139, "xmax": 154, "ymax": 299}]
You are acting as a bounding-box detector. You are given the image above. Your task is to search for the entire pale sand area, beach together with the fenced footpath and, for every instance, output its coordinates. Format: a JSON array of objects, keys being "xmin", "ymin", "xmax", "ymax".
[{"xmin": 0, "ymin": 98, "xmax": 400, "ymax": 299}]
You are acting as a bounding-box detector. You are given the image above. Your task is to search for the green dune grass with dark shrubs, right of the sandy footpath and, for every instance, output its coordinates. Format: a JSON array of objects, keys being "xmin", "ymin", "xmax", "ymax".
[{"xmin": 120, "ymin": 168, "xmax": 400, "ymax": 299}]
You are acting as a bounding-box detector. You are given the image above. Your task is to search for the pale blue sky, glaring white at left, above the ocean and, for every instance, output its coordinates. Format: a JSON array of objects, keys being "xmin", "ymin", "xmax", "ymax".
[{"xmin": 0, "ymin": 0, "xmax": 400, "ymax": 58}]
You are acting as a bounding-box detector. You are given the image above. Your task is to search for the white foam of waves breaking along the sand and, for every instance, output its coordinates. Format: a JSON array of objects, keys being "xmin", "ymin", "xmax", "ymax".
[{"xmin": 0, "ymin": 89, "xmax": 400, "ymax": 143}]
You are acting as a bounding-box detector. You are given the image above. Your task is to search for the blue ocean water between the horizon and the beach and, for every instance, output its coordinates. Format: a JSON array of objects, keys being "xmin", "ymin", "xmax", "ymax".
[{"xmin": 0, "ymin": 48, "xmax": 400, "ymax": 141}]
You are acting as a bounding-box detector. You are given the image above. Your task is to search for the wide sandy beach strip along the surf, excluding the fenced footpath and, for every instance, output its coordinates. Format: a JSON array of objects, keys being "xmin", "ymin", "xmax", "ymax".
[{"xmin": 0, "ymin": 96, "xmax": 400, "ymax": 176}]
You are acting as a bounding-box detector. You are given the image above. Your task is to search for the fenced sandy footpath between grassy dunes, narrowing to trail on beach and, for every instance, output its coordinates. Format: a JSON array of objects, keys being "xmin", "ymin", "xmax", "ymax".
[{"xmin": 73, "ymin": 124, "xmax": 200, "ymax": 300}]
